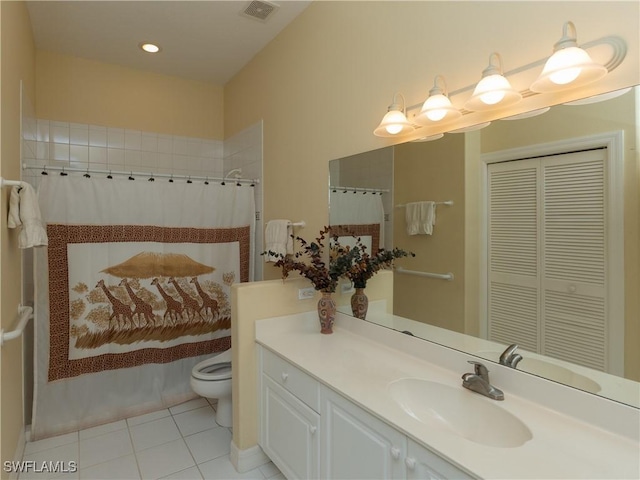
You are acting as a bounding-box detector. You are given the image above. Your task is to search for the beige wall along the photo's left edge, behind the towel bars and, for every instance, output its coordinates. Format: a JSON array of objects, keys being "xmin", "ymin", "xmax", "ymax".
[{"xmin": 0, "ymin": 1, "xmax": 35, "ymax": 472}]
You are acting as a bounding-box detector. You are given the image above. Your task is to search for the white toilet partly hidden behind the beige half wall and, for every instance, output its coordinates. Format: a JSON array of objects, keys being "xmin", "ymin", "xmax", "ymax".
[{"xmin": 191, "ymin": 349, "xmax": 233, "ymax": 427}]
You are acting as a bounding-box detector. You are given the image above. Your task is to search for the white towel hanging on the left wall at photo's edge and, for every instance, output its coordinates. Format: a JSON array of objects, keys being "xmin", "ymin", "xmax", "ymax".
[{"xmin": 7, "ymin": 182, "xmax": 49, "ymax": 248}]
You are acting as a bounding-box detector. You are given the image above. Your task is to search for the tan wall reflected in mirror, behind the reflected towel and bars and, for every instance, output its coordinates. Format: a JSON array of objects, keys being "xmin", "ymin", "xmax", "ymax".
[{"xmin": 393, "ymin": 135, "xmax": 466, "ymax": 333}]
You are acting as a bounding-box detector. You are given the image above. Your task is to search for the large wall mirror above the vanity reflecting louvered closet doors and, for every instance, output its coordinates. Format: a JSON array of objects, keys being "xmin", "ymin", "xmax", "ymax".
[{"xmin": 329, "ymin": 87, "xmax": 640, "ymax": 407}]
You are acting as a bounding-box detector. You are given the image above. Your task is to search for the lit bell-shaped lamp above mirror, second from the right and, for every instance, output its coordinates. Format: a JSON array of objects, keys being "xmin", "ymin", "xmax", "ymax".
[{"xmin": 464, "ymin": 52, "xmax": 522, "ymax": 111}]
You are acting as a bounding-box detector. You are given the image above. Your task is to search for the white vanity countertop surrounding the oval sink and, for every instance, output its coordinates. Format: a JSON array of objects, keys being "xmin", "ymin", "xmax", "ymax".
[{"xmin": 256, "ymin": 312, "xmax": 640, "ymax": 479}]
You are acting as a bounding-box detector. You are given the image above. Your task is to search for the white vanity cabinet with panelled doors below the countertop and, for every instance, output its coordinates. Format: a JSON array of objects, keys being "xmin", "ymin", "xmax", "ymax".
[{"xmin": 259, "ymin": 347, "xmax": 473, "ymax": 480}]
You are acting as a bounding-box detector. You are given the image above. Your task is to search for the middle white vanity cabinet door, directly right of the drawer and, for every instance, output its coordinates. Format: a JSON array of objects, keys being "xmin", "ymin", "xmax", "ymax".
[{"xmin": 320, "ymin": 388, "xmax": 406, "ymax": 480}]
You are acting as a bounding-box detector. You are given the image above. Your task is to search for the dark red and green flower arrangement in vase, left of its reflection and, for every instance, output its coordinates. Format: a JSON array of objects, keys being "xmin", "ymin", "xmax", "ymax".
[{"xmin": 263, "ymin": 227, "xmax": 359, "ymax": 293}]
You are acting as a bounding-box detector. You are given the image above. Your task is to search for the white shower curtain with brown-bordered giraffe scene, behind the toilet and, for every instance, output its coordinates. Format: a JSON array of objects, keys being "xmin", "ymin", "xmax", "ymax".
[{"xmin": 31, "ymin": 176, "xmax": 255, "ymax": 439}]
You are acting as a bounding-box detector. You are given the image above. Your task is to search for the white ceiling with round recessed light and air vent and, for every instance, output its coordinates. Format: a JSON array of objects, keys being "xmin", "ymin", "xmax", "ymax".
[{"xmin": 27, "ymin": 0, "xmax": 311, "ymax": 85}]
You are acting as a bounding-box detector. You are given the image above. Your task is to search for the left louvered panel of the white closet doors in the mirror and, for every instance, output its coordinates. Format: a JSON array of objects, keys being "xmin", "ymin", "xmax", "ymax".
[{"xmin": 487, "ymin": 160, "xmax": 540, "ymax": 352}]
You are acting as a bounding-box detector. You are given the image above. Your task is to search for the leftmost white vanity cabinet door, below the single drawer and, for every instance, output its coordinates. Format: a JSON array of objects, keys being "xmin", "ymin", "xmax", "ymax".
[{"xmin": 261, "ymin": 375, "xmax": 320, "ymax": 479}]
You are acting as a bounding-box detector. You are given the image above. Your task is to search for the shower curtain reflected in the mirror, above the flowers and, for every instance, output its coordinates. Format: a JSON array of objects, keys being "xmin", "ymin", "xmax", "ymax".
[{"xmin": 329, "ymin": 191, "xmax": 384, "ymax": 253}]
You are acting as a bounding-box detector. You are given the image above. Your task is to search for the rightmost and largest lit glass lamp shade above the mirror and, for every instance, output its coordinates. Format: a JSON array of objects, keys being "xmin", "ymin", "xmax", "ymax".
[{"xmin": 529, "ymin": 22, "xmax": 607, "ymax": 93}]
